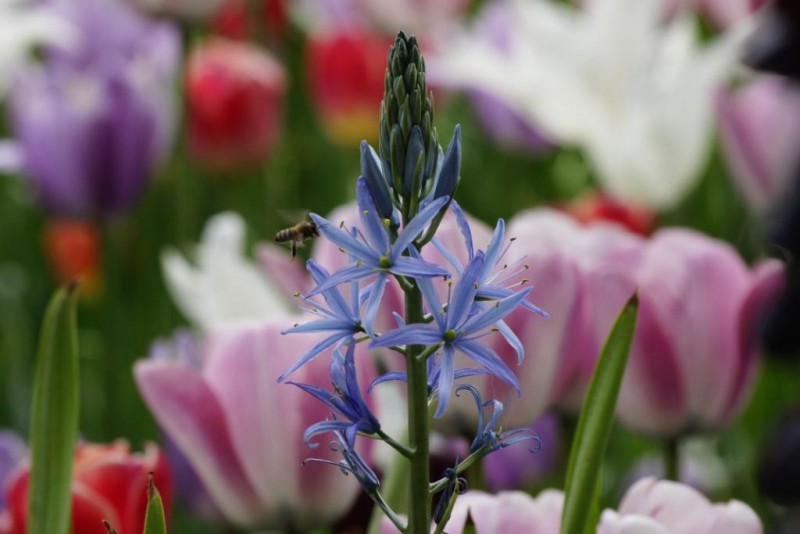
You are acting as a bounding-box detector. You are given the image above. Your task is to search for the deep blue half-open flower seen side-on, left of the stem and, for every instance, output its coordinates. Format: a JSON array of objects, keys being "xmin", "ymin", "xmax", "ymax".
[{"xmin": 287, "ymin": 339, "xmax": 381, "ymax": 448}]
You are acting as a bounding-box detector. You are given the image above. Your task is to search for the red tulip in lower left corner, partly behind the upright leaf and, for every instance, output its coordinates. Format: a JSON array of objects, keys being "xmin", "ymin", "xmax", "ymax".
[{"xmin": 0, "ymin": 440, "xmax": 172, "ymax": 534}]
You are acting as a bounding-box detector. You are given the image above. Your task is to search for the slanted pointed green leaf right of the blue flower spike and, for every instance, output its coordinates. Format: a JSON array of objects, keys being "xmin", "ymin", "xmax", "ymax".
[{"xmin": 561, "ymin": 295, "xmax": 639, "ymax": 534}]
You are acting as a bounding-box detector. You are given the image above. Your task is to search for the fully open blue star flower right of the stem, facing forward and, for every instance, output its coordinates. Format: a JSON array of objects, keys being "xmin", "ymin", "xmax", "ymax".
[{"xmin": 370, "ymin": 251, "xmax": 531, "ymax": 417}]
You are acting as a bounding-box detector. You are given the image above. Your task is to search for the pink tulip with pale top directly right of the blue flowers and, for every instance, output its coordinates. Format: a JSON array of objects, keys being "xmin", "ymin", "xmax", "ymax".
[{"xmin": 491, "ymin": 209, "xmax": 643, "ymax": 427}]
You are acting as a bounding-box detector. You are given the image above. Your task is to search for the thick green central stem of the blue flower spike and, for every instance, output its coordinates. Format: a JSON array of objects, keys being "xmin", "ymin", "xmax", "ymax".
[{"xmin": 405, "ymin": 287, "xmax": 431, "ymax": 534}]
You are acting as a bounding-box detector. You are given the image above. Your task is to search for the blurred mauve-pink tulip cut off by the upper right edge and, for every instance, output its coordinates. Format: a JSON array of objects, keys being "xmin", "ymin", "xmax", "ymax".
[{"xmin": 717, "ymin": 75, "xmax": 800, "ymax": 211}]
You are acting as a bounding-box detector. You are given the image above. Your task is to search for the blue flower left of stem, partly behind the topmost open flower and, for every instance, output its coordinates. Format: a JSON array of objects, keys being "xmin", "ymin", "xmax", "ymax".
[{"xmin": 278, "ymin": 259, "xmax": 360, "ymax": 382}]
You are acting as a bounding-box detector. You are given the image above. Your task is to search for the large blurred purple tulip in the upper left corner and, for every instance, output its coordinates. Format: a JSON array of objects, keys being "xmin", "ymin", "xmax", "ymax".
[{"xmin": 9, "ymin": 0, "xmax": 180, "ymax": 217}]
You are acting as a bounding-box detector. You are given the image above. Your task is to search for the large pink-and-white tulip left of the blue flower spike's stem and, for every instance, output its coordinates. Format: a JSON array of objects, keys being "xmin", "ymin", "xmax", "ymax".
[{"xmin": 134, "ymin": 320, "xmax": 374, "ymax": 531}]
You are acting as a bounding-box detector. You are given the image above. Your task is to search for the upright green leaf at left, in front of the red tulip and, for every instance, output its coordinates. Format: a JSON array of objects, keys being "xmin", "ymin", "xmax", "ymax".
[{"xmin": 28, "ymin": 285, "xmax": 79, "ymax": 534}]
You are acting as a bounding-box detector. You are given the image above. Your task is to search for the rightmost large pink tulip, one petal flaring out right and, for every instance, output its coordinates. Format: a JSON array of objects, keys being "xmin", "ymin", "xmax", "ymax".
[{"xmin": 617, "ymin": 229, "xmax": 784, "ymax": 436}]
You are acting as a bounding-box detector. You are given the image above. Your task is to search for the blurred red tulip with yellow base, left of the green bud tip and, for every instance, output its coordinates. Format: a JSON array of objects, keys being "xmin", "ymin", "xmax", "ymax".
[{"xmin": 306, "ymin": 29, "xmax": 392, "ymax": 147}]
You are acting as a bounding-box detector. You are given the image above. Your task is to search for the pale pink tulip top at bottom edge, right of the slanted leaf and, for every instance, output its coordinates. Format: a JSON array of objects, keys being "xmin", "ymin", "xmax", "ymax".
[{"xmin": 597, "ymin": 478, "xmax": 763, "ymax": 534}]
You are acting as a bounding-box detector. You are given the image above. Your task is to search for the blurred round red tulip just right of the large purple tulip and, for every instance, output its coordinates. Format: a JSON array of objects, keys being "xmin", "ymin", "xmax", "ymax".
[{"xmin": 186, "ymin": 38, "xmax": 286, "ymax": 170}]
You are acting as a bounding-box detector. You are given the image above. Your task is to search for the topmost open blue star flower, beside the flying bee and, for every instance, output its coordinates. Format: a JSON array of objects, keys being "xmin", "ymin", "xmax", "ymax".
[{"xmin": 308, "ymin": 177, "xmax": 450, "ymax": 337}]
